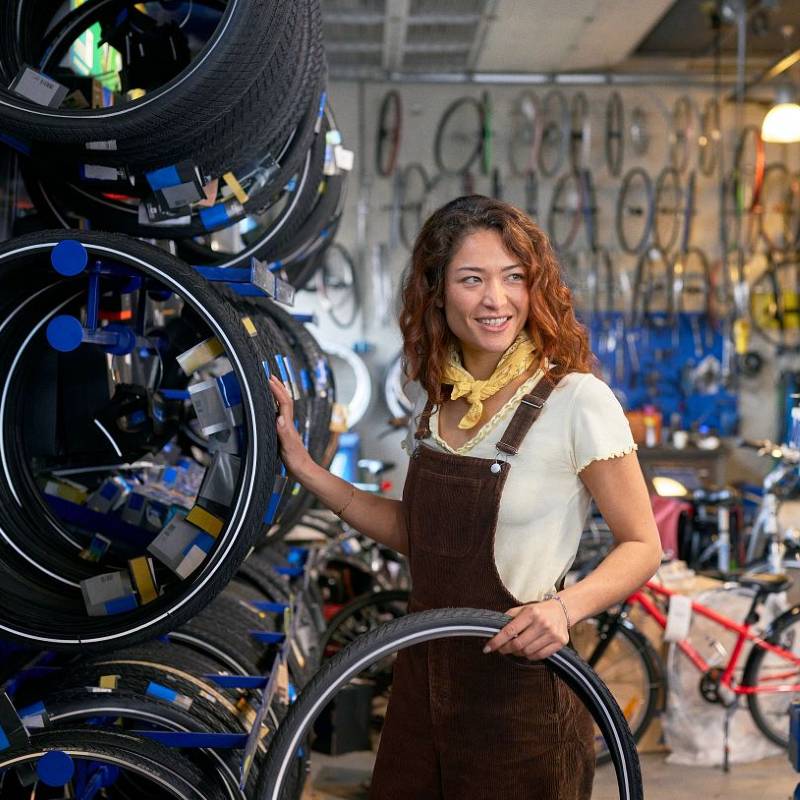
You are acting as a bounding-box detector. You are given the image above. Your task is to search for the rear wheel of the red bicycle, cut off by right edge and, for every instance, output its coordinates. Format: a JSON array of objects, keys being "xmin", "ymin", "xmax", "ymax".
[{"xmin": 742, "ymin": 608, "xmax": 800, "ymax": 748}]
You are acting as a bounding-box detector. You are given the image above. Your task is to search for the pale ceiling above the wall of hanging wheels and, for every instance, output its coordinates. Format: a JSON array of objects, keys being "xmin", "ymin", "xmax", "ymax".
[{"xmin": 322, "ymin": 0, "xmax": 800, "ymax": 79}]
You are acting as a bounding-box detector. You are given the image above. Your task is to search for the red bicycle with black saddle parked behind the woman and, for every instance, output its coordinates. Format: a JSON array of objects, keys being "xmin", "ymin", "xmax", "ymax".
[{"xmin": 572, "ymin": 574, "xmax": 800, "ymax": 762}]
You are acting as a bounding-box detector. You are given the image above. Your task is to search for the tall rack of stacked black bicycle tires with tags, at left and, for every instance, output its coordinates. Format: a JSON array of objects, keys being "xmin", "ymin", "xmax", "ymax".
[{"xmin": 0, "ymin": 0, "xmax": 349, "ymax": 798}]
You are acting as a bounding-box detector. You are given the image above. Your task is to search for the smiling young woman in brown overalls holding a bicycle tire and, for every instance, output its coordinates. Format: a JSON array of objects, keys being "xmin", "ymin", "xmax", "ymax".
[{"xmin": 272, "ymin": 196, "xmax": 661, "ymax": 800}]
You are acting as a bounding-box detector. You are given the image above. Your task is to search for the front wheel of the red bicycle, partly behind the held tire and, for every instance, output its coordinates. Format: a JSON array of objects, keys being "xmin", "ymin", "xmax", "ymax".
[{"xmin": 570, "ymin": 614, "xmax": 664, "ymax": 764}]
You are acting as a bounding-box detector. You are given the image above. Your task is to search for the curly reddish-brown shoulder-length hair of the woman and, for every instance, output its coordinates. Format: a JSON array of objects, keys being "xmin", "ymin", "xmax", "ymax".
[{"xmin": 400, "ymin": 195, "xmax": 593, "ymax": 404}]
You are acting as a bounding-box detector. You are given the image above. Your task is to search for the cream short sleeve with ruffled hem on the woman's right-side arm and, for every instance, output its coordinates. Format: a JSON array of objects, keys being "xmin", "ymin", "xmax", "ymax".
[{"xmin": 570, "ymin": 374, "xmax": 637, "ymax": 473}]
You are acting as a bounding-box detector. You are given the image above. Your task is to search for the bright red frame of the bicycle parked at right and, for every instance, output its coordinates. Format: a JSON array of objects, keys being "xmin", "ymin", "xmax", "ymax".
[{"xmin": 626, "ymin": 581, "xmax": 800, "ymax": 695}]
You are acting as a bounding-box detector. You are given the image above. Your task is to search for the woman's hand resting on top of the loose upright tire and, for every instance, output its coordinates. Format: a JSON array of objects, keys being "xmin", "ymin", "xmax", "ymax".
[{"xmin": 483, "ymin": 600, "xmax": 569, "ymax": 660}]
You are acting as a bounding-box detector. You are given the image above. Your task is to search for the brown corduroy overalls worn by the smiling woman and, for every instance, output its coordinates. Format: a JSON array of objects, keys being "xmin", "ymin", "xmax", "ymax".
[{"xmin": 369, "ymin": 382, "xmax": 595, "ymax": 800}]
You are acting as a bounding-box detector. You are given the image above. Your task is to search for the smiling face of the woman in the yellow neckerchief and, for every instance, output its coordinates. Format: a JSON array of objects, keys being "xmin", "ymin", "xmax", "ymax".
[{"xmin": 444, "ymin": 229, "xmax": 530, "ymax": 356}]
